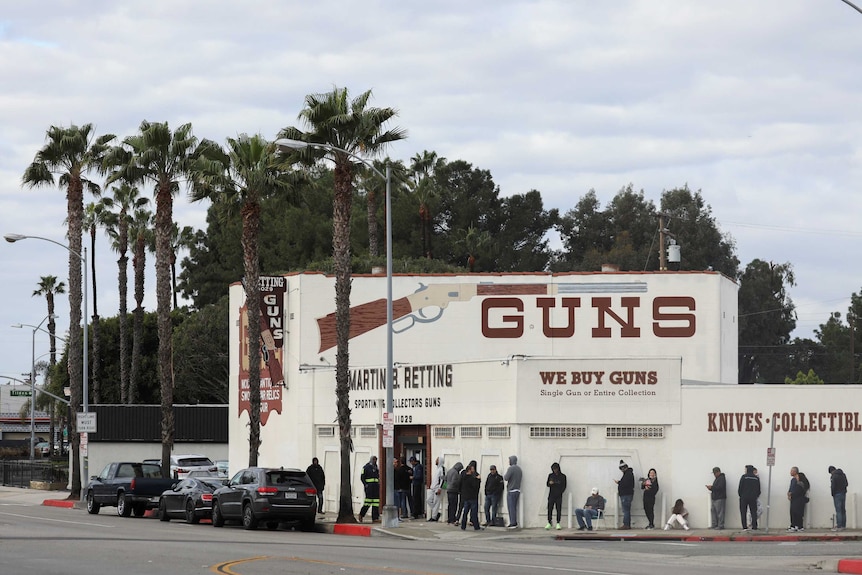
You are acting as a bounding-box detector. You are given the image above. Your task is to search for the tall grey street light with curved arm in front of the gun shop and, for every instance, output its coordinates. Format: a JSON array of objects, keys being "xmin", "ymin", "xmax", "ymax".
[{"xmin": 275, "ymin": 138, "xmax": 398, "ymax": 527}]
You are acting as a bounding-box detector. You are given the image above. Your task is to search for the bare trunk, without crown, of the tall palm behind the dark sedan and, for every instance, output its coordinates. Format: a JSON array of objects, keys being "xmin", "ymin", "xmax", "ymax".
[{"xmin": 155, "ymin": 182, "xmax": 174, "ymax": 477}]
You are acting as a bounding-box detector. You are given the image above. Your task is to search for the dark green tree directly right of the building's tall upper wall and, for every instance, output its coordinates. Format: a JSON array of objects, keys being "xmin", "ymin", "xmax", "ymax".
[{"xmin": 739, "ymin": 259, "xmax": 796, "ymax": 383}]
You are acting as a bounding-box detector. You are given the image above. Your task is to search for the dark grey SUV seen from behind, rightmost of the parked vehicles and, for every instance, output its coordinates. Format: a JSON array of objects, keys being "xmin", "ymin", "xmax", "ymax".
[{"xmin": 212, "ymin": 467, "xmax": 317, "ymax": 531}]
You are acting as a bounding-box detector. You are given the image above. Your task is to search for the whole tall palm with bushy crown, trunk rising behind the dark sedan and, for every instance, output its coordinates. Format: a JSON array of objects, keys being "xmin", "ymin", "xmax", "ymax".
[{"xmin": 107, "ymin": 120, "xmax": 219, "ymax": 477}]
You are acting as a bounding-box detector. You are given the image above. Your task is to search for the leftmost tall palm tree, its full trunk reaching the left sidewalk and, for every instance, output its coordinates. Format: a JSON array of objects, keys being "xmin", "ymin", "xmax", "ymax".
[{"xmin": 21, "ymin": 124, "xmax": 115, "ymax": 499}]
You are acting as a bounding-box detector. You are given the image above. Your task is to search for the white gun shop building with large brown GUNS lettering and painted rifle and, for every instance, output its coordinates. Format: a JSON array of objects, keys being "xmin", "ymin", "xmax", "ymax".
[{"xmin": 229, "ymin": 271, "xmax": 862, "ymax": 528}]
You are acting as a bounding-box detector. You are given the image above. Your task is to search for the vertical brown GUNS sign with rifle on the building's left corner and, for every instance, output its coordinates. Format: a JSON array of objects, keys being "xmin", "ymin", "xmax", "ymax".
[{"xmin": 239, "ymin": 276, "xmax": 287, "ymax": 425}]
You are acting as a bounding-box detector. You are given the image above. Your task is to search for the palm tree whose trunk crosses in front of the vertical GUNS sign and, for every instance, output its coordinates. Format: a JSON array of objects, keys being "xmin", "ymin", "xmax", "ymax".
[{"xmin": 192, "ymin": 134, "xmax": 287, "ymax": 467}]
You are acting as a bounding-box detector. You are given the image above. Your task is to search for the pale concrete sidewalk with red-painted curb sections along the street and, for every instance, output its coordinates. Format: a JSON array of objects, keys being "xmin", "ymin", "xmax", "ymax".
[{"xmin": 0, "ymin": 486, "xmax": 862, "ymax": 574}]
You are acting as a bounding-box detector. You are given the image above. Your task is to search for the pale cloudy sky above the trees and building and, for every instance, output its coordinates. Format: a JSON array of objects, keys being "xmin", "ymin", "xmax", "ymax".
[{"xmin": 0, "ymin": 0, "xmax": 862, "ymax": 388}]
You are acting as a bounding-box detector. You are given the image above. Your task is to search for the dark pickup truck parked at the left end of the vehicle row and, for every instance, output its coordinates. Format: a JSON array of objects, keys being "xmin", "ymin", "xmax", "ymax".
[{"xmin": 86, "ymin": 461, "xmax": 175, "ymax": 517}]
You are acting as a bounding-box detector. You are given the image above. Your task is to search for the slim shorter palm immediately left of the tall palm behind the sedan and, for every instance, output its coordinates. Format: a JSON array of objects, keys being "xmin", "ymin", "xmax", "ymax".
[{"xmin": 126, "ymin": 207, "xmax": 153, "ymax": 404}]
